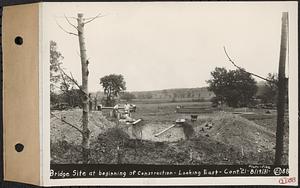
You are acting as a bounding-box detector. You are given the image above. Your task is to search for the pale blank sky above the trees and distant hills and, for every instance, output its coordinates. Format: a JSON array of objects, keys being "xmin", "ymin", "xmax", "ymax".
[{"xmin": 42, "ymin": 2, "xmax": 298, "ymax": 91}]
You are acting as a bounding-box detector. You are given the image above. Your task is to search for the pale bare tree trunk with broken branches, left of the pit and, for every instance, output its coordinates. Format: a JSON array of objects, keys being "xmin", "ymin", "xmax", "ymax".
[{"xmin": 77, "ymin": 13, "xmax": 90, "ymax": 164}]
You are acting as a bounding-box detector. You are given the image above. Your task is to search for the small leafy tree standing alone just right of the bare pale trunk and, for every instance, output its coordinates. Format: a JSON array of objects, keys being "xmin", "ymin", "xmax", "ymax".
[{"xmin": 100, "ymin": 74, "xmax": 126, "ymax": 106}]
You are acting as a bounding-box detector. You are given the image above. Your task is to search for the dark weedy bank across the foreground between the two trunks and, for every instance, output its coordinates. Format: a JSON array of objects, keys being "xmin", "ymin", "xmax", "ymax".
[{"xmin": 90, "ymin": 125, "xmax": 273, "ymax": 165}]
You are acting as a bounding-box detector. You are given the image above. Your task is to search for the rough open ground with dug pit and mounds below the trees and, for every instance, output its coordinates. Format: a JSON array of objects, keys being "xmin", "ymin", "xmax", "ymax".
[{"xmin": 51, "ymin": 102, "xmax": 288, "ymax": 164}]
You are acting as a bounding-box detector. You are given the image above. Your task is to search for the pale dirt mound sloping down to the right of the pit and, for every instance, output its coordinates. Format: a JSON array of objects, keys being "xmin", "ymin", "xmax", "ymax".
[{"xmin": 195, "ymin": 113, "xmax": 275, "ymax": 153}]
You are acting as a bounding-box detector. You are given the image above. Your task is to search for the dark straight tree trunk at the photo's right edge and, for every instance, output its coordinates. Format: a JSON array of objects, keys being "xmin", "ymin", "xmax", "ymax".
[{"xmin": 274, "ymin": 12, "xmax": 288, "ymax": 165}]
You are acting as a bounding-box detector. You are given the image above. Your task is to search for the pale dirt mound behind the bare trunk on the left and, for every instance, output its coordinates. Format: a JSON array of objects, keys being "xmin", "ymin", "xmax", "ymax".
[{"xmin": 50, "ymin": 109, "xmax": 114, "ymax": 145}]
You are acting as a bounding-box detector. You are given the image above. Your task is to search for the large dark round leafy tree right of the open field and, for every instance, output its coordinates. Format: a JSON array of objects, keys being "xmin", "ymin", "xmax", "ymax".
[{"xmin": 207, "ymin": 67, "xmax": 257, "ymax": 107}]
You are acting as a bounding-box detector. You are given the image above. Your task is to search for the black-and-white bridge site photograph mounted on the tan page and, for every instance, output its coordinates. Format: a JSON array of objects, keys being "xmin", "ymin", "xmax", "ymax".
[{"xmin": 43, "ymin": 2, "xmax": 298, "ymax": 184}]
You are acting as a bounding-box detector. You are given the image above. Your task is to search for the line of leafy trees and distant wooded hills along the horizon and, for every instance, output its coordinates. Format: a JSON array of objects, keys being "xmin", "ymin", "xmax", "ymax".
[{"xmin": 50, "ymin": 41, "xmax": 278, "ymax": 108}]
